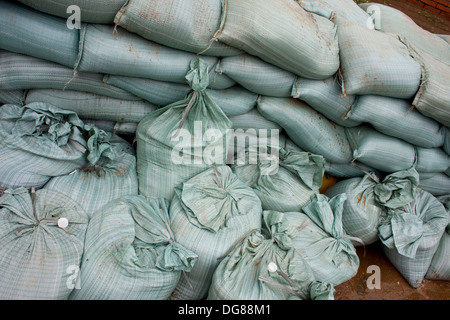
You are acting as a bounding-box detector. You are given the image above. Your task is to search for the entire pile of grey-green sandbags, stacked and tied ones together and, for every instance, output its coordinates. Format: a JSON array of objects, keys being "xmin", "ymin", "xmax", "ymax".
[{"xmin": 0, "ymin": 0, "xmax": 450, "ymax": 300}]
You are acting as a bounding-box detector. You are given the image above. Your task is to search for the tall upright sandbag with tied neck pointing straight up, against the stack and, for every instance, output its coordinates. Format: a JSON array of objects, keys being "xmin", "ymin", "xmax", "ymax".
[{"xmin": 136, "ymin": 58, "xmax": 232, "ymax": 201}]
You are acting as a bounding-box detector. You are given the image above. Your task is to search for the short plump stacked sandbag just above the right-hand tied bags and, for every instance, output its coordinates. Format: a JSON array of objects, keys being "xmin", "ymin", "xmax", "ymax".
[{"xmin": 346, "ymin": 125, "xmax": 416, "ymax": 173}]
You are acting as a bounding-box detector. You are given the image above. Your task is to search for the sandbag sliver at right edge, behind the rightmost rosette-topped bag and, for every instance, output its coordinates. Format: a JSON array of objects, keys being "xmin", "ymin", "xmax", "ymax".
[{"xmin": 425, "ymin": 195, "xmax": 450, "ymax": 281}]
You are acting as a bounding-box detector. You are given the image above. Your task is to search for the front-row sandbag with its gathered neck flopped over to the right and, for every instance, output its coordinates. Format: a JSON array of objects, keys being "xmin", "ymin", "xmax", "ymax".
[{"xmin": 69, "ymin": 195, "xmax": 197, "ymax": 300}]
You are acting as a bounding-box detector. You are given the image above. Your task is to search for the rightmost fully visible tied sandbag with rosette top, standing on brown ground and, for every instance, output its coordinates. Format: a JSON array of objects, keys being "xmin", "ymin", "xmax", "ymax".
[{"xmin": 378, "ymin": 189, "xmax": 448, "ymax": 288}]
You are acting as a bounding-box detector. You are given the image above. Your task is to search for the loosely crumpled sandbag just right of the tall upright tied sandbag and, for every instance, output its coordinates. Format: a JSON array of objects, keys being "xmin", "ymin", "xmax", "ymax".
[{"xmin": 231, "ymin": 145, "xmax": 325, "ymax": 212}]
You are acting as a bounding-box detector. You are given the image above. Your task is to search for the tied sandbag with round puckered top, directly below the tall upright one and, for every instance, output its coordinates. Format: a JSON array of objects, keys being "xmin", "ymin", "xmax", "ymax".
[{"xmin": 170, "ymin": 165, "xmax": 262, "ymax": 300}]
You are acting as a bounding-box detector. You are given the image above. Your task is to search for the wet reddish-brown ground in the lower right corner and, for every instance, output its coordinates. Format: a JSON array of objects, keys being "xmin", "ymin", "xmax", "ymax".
[{"xmin": 335, "ymin": 242, "xmax": 450, "ymax": 300}]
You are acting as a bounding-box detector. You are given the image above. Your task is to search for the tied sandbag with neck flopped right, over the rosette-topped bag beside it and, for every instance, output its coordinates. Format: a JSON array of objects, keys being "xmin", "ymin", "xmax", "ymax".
[{"xmin": 325, "ymin": 168, "xmax": 419, "ymax": 246}]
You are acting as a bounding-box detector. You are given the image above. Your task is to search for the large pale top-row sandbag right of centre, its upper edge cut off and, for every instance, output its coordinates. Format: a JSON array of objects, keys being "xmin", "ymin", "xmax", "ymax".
[{"xmin": 216, "ymin": 0, "xmax": 339, "ymax": 79}]
